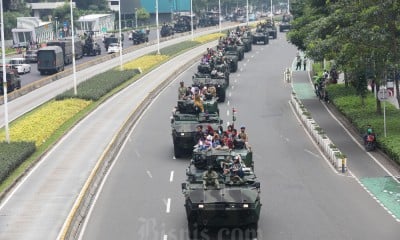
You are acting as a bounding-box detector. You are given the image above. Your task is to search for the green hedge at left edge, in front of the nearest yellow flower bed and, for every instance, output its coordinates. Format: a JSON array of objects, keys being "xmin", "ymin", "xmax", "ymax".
[{"xmin": 0, "ymin": 142, "xmax": 36, "ymax": 182}]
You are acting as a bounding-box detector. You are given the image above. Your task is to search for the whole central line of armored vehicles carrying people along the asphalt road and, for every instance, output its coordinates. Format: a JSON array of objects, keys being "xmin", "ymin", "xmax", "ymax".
[{"xmin": 167, "ymin": 26, "xmax": 262, "ymax": 239}]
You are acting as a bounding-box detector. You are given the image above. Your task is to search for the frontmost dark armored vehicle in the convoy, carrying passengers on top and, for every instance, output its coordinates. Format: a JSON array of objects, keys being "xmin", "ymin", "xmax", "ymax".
[{"xmin": 182, "ymin": 149, "xmax": 262, "ymax": 239}]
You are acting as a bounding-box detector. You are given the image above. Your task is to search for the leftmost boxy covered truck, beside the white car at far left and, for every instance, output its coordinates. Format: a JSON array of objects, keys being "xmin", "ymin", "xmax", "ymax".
[{"xmin": 37, "ymin": 46, "xmax": 64, "ymax": 75}]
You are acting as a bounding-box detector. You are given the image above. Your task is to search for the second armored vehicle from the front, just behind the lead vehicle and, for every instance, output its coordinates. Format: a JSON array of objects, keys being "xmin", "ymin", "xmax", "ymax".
[{"xmin": 171, "ymin": 99, "xmax": 222, "ymax": 158}]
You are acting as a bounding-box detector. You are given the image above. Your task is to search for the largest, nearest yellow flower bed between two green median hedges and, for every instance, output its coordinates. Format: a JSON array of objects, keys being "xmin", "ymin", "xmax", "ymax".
[{"xmin": 0, "ymin": 99, "xmax": 91, "ymax": 147}]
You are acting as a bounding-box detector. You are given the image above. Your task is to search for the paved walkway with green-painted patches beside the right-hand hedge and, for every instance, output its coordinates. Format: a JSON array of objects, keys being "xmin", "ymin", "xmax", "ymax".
[{"xmin": 292, "ymin": 66, "xmax": 400, "ymax": 221}]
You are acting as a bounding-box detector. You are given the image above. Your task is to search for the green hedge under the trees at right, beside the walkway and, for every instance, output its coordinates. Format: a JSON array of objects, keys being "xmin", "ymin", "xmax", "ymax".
[{"xmin": 327, "ymin": 84, "xmax": 400, "ymax": 164}]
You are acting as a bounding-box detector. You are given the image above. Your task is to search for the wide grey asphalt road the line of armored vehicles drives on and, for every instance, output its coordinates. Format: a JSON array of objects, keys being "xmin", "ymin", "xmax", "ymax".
[{"xmin": 80, "ymin": 34, "xmax": 400, "ymax": 240}]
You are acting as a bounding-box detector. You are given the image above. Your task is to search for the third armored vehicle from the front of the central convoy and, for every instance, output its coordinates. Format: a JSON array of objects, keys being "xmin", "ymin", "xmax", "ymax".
[{"xmin": 192, "ymin": 72, "xmax": 229, "ymax": 102}]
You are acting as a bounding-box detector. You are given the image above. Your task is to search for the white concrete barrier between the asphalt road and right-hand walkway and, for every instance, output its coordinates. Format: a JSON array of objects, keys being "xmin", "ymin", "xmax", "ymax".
[{"xmin": 290, "ymin": 92, "xmax": 347, "ymax": 173}]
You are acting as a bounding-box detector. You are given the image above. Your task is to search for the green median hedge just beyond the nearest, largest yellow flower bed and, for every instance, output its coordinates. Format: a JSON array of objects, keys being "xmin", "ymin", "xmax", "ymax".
[{"xmin": 55, "ymin": 69, "xmax": 140, "ymax": 101}]
